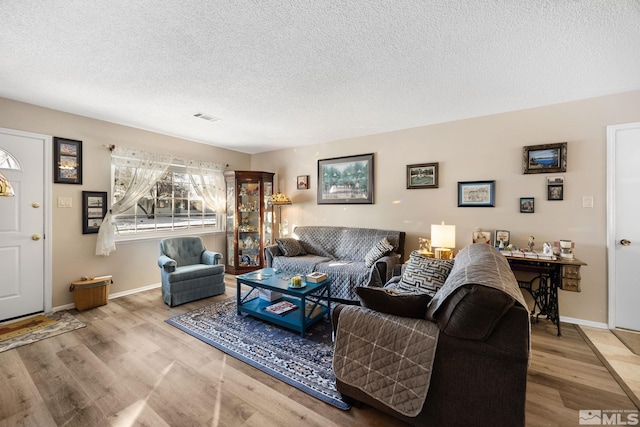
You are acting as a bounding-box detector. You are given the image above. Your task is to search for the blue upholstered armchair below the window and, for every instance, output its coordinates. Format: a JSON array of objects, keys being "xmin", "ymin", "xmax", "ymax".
[{"xmin": 158, "ymin": 237, "xmax": 225, "ymax": 307}]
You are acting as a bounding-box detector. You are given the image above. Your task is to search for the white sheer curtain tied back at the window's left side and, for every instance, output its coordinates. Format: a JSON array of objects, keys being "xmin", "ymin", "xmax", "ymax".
[{"xmin": 96, "ymin": 147, "xmax": 173, "ymax": 256}]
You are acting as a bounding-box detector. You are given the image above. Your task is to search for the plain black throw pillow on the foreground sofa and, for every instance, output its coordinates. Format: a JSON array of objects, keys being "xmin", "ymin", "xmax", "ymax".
[{"xmin": 356, "ymin": 286, "xmax": 431, "ymax": 319}]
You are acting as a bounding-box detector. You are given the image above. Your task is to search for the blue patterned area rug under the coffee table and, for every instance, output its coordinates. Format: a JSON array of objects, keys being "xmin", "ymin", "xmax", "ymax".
[{"xmin": 166, "ymin": 297, "xmax": 350, "ymax": 410}]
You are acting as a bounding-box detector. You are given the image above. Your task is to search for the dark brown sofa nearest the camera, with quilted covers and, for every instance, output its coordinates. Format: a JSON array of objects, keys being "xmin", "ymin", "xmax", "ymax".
[{"xmin": 332, "ymin": 243, "xmax": 531, "ymax": 426}]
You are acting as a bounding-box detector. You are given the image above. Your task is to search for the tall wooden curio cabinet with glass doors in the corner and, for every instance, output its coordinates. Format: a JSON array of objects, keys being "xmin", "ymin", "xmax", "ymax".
[{"xmin": 224, "ymin": 171, "xmax": 274, "ymax": 274}]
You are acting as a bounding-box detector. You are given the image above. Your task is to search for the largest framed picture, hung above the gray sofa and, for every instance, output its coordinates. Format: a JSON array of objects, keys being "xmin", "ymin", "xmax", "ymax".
[{"xmin": 318, "ymin": 153, "xmax": 374, "ymax": 205}]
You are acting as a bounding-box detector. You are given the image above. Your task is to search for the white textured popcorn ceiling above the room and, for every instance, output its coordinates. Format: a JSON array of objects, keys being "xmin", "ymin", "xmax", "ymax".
[{"xmin": 0, "ymin": 0, "xmax": 640, "ymax": 153}]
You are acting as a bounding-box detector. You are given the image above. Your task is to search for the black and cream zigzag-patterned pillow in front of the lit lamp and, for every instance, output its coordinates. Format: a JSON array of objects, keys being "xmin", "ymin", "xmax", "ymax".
[{"xmin": 398, "ymin": 251, "xmax": 454, "ymax": 296}]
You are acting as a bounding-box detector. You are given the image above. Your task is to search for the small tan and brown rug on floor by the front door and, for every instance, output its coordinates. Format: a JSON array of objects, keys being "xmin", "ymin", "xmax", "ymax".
[{"xmin": 0, "ymin": 311, "xmax": 86, "ymax": 353}]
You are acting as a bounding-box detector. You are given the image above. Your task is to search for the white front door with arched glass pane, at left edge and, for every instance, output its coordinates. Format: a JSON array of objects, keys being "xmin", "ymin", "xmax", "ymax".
[{"xmin": 0, "ymin": 128, "xmax": 51, "ymax": 321}]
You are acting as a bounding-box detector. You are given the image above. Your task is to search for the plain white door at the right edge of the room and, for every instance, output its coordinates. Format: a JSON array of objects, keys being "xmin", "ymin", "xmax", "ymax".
[{"xmin": 607, "ymin": 123, "xmax": 640, "ymax": 331}]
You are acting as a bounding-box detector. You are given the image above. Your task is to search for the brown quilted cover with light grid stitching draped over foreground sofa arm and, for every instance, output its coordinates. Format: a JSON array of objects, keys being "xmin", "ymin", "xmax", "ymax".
[{"xmin": 333, "ymin": 306, "xmax": 439, "ymax": 417}]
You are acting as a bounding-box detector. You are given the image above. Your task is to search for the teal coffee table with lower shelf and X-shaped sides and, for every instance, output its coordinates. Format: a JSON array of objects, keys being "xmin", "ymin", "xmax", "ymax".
[{"xmin": 236, "ymin": 268, "xmax": 331, "ymax": 337}]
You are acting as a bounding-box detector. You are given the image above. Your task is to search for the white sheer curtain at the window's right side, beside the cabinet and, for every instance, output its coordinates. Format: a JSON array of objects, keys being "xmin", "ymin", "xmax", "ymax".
[{"xmin": 185, "ymin": 160, "xmax": 226, "ymax": 213}]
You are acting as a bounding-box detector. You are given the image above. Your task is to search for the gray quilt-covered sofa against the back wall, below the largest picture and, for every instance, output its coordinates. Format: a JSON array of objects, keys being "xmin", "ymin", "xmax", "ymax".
[{"xmin": 264, "ymin": 226, "xmax": 405, "ymax": 301}]
